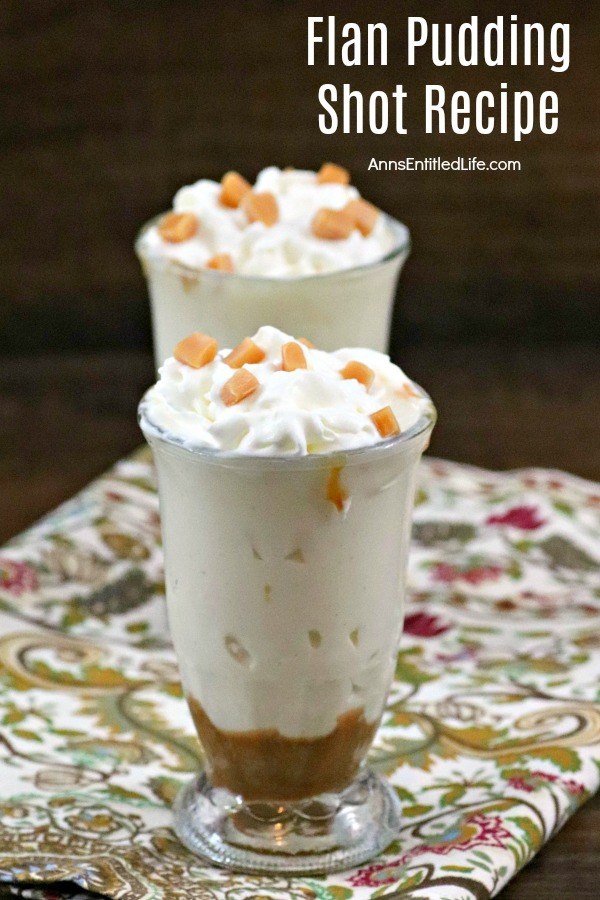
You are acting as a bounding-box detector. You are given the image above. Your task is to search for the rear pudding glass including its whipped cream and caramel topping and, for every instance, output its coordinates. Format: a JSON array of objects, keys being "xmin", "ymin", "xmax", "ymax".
[{"xmin": 136, "ymin": 169, "xmax": 410, "ymax": 370}]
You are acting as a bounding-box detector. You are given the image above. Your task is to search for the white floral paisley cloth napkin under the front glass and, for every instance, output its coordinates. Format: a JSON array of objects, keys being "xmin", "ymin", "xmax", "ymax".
[{"xmin": 0, "ymin": 452, "xmax": 600, "ymax": 900}]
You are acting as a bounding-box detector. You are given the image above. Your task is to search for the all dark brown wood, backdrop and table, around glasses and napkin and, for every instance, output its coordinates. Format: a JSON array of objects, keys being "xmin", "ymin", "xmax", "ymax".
[{"xmin": 0, "ymin": 0, "xmax": 600, "ymax": 900}]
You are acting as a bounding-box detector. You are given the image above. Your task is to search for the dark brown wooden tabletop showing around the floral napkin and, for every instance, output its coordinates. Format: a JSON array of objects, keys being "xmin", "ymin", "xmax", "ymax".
[{"xmin": 0, "ymin": 344, "xmax": 600, "ymax": 900}]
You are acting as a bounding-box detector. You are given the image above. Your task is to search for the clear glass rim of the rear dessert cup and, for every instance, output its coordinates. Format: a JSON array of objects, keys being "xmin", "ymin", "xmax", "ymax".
[{"xmin": 134, "ymin": 210, "xmax": 412, "ymax": 285}]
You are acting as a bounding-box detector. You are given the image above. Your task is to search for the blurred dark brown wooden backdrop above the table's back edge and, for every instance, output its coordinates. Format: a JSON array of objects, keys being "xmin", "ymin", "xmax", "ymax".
[{"xmin": 0, "ymin": 0, "xmax": 600, "ymax": 352}]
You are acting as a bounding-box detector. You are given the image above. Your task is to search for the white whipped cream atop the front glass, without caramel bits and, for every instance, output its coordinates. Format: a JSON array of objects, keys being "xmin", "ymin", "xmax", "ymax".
[{"xmin": 142, "ymin": 326, "xmax": 432, "ymax": 456}]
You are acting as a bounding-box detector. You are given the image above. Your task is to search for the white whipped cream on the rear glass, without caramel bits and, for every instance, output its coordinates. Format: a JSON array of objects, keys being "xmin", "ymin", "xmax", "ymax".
[{"xmin": 138, "ymin": 166, "xmax": 408, "ymax": 278}]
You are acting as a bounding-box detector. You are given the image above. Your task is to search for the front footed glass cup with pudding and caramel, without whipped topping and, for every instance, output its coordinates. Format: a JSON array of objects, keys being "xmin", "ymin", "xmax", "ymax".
[{"xmin": 140, "ymin": 400, "xmax": 435, "ymax": 873}]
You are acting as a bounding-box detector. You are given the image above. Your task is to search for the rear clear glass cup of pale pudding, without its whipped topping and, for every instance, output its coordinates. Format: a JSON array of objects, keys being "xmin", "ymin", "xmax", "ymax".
[{"xmin": 136, "ymin": 216, "xmax": 410, "ymax": 370}]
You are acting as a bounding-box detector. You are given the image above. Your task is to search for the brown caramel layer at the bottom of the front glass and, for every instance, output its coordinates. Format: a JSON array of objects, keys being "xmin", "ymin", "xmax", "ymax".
[{"xmin": 188, "ymin": 697, "xmax": 377, "ymax": 800}]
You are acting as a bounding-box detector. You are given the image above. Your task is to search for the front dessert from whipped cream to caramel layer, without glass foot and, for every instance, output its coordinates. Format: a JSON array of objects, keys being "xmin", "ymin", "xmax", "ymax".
[{"xmin": 140, "ymin": 327, "xmax": 435, "ymax": 800}]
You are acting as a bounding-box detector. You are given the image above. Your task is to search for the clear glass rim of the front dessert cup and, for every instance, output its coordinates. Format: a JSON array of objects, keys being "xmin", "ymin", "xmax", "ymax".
[{"xmin": 138, "ymin": 385, "xmax": 437, "ymax": 470}]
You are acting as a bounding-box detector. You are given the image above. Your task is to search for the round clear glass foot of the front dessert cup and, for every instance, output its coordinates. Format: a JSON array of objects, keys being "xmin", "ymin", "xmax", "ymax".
[{"xmin": 174, "ymin": 769, "xmax": 400, "ymax": 875}]
